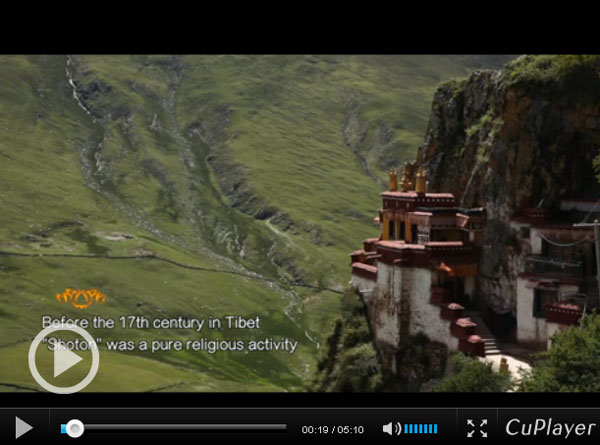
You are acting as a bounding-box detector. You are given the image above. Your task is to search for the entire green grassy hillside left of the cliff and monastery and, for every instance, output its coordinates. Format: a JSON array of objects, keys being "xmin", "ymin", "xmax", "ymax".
[{"xmin": 0, "ymin": 56, "xmax": 509, "ymax": 391}]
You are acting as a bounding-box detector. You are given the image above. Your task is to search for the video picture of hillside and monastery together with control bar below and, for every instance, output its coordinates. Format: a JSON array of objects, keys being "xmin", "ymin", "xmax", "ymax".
[{"xmin": 0, "ymin": 54, "xmax": 600, "ymax": 443}]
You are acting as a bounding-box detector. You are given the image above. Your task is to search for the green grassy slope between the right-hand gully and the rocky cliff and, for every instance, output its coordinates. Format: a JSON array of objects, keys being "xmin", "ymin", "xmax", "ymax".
[{"xmin": 177, "ymin": 56, "xmax": 506, "ymax": 285}]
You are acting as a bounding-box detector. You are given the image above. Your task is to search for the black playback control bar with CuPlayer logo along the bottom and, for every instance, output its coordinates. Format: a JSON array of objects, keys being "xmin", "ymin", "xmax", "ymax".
[{"xmin": 0, "ymin": 407, "xmax": 600, "ymax": 445}]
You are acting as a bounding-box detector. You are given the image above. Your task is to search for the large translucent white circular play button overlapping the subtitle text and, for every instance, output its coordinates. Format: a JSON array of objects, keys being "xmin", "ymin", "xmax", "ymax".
[{"xmin": 29, "ymin": 323, "xmax": 100, "ymax": 394}]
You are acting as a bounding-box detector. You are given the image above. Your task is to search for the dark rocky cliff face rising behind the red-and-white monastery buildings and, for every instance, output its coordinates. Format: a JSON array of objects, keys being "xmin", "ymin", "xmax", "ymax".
[{"xmin": 418, "ymin": 56, "xmax": 600, "ymax": 314}]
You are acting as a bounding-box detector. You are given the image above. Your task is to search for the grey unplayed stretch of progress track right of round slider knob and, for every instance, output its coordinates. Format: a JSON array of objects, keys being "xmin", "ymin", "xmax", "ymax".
[{"xmin": 85, "ymin": 423, "xmax": 287, "ymax": 431}]
